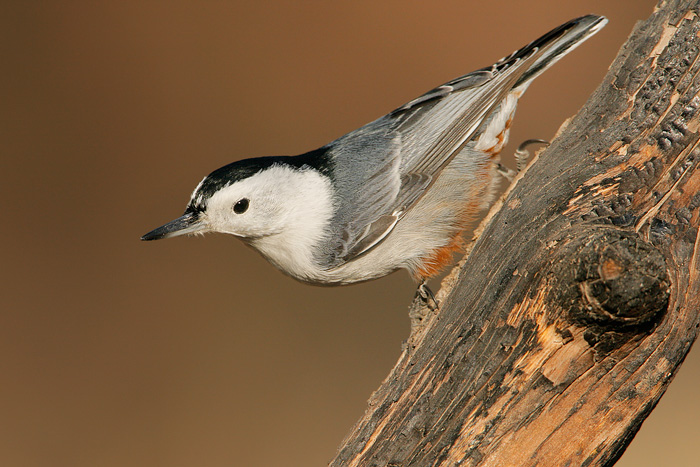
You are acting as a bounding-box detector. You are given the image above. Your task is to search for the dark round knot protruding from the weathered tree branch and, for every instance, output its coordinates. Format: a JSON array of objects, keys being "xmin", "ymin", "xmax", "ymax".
[{"xmin": 552, "ymin": 228, "xmax": 670, "ymax": 331}]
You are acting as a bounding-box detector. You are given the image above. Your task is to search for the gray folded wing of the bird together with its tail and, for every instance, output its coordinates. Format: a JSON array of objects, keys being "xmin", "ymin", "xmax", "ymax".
[{"xmin": 323, "ymin": 15, "xmax": 606, "ymax": 267}]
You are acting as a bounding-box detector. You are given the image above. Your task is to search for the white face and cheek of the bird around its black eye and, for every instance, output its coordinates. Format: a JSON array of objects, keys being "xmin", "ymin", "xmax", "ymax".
[{"xmin": 197, "ymin": 165, "xmax": 332, "ymax": 240}]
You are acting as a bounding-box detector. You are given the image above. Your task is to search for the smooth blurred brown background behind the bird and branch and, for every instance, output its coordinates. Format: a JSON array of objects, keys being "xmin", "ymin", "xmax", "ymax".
[{"xmin": 0, "ymin": 0, "xmax": 700, "ymax": 466}]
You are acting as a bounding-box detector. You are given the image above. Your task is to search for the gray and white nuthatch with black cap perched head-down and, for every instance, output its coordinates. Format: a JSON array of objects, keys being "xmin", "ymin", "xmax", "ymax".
[{"xmin": 141, "ymin": 15, "xmax": 607, "ymax": 291}]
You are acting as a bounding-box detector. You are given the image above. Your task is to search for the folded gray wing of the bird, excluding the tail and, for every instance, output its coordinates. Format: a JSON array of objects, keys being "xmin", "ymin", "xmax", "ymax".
[{"xmin": 325, "ymin": 59, "xmax": 532, "ymax": 266}]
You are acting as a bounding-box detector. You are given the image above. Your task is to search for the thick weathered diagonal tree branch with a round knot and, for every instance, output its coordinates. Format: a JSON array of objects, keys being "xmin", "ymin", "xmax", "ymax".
[{"xmin": 331, "ymin": 0, "xmax": 700, "ymax": 467}]
